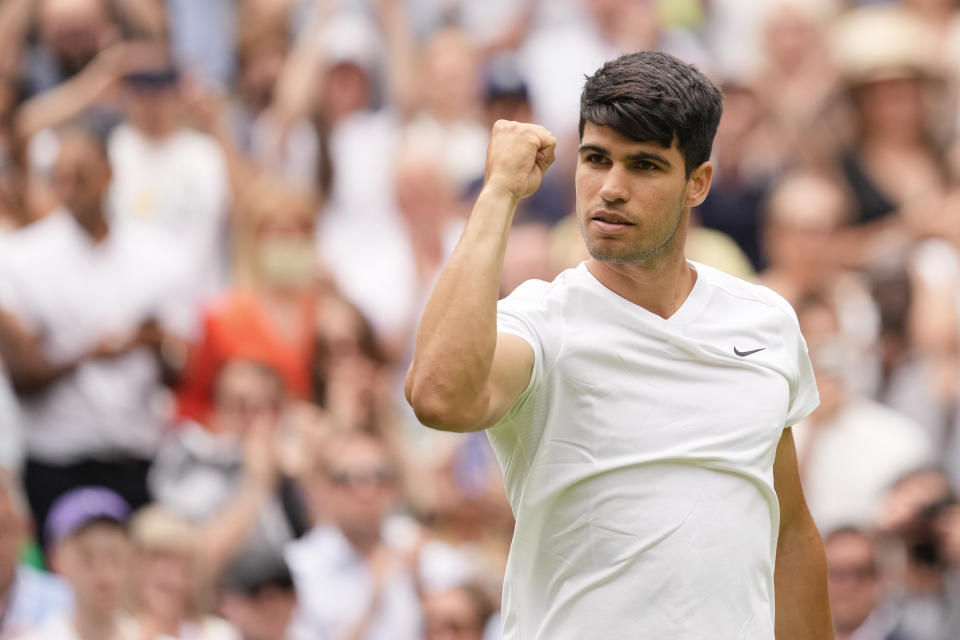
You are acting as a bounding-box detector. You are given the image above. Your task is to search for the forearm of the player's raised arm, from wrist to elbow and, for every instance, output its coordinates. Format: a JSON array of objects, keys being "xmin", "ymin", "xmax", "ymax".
[{"xmin": 407, "ymin": 187, "xmax": 517, "ymax": 418}]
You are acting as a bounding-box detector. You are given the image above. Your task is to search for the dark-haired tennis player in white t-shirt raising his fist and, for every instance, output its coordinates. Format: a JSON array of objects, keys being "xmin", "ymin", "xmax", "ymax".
[{"xmin": 407, "ymin": 52, "xmax": 833, "ymax": 640}]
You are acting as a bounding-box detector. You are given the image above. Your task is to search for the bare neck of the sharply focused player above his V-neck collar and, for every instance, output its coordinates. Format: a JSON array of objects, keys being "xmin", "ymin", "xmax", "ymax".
[{"xmin": 587, "ymin": 243, "xmax": 697, "ymax": 318}]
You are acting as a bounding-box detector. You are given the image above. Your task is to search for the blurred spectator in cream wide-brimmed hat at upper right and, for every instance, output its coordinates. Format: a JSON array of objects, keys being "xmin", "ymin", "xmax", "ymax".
[{"xmin": 836, "ymin": 6, "xmax": 947, "ymax": 230}]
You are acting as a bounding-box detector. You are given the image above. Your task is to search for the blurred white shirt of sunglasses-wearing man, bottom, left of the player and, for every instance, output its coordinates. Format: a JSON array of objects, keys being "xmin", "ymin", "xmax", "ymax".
[{"xmin": 285, "ymin": 518, "xmax": 469, "ymax": 640}]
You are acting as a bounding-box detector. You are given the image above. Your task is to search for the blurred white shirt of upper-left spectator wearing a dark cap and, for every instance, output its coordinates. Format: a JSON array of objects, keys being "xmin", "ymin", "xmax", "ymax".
[{"xmin": 108, "ymin": 124, "xmax": 230, "ymax": 300}]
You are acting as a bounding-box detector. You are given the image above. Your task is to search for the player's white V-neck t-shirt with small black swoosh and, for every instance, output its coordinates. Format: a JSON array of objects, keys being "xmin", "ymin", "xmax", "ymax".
[{"xmin": 488, "ymin": 263, "xmax": 819, "ymax": 640}]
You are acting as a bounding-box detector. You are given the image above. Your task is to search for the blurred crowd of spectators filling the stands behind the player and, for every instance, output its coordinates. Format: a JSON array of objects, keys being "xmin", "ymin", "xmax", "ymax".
[{"xmin": 0, "ymin": 0, "xmax": 960, "ymax": 640}]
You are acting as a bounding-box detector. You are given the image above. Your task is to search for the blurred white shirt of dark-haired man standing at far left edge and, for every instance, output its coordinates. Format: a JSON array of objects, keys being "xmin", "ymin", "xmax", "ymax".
[{"xmin": 0, "ymin": 210, "xmax": 194, "ymax": 464}]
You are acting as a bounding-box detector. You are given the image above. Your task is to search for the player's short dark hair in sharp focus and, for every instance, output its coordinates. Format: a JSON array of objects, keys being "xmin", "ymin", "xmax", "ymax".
[{"xmin": 580, "ymin": 51, "xmax": 723, "ymax": 176}]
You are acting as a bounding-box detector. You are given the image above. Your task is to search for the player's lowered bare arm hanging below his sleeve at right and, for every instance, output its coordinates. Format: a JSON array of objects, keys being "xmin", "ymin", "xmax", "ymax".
[{"xmin": 773, "ymin": 429, "xmax": 833, "ymax": 640}]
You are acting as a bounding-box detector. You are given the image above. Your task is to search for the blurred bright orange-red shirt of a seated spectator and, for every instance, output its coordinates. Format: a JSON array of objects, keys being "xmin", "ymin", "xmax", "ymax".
[{"xmin": 177, "ymin": 290, "xmax": 316, "ymax": 423}]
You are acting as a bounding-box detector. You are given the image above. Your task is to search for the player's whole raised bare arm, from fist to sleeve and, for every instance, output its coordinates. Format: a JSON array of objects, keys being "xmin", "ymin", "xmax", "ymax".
[{"xmin": 406, "ymin": 120, "xmax": 557, "ymax": 431}]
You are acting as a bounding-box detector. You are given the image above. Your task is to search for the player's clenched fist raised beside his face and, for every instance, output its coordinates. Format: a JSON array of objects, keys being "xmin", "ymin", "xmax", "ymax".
[{"xmin": 484, "ymin": 120, "xmax": 557, "ymax": 198}]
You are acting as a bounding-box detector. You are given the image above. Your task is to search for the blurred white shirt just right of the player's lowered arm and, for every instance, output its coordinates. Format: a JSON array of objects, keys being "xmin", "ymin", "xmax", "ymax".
[{"xmin": 794, "ymin": 398, "xmax": 933, "ymax": 534}]
